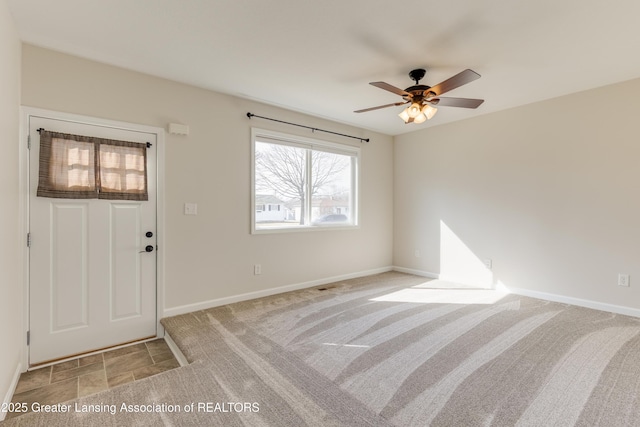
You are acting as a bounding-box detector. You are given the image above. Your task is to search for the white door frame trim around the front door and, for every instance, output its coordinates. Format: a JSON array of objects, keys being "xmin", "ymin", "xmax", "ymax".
[{"xmin": 19, "ymin": 106, "xmax": 165, "ymax": 372}]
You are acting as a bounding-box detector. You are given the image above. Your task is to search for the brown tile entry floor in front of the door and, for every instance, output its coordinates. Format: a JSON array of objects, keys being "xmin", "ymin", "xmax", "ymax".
[{"xmin": 6, "ymin": 339, "xmax": 180, "ymax": 419}]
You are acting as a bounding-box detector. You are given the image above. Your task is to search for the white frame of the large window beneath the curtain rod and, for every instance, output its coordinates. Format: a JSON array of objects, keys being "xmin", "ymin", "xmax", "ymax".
[{"xmin": 251, "ymin": 128, "xmax": 361, "ymax": 234}]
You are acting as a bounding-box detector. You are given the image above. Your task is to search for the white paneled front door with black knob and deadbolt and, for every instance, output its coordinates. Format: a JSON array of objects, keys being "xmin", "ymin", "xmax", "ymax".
[{"xmin": 28, "ymin": 115, "xmax": 157, "ymax": 365}]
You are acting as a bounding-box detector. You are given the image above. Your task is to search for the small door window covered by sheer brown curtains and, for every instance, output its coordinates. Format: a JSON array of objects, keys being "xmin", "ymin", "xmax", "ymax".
[{"xmin": 37, "ymin": 129, "xmax": 149, "ymax": 200}]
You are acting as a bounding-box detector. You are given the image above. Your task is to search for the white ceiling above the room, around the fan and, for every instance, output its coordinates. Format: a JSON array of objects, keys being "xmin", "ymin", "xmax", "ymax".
[{"xmin": 6, "ymin": 0, "xmax": 640, "ymax": 135}]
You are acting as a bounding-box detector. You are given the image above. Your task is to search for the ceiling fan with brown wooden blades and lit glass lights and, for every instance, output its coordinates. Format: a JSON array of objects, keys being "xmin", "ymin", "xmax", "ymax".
[{"xmin": 354, "ymin": 68, "xmax": 484, "ymax": 123}]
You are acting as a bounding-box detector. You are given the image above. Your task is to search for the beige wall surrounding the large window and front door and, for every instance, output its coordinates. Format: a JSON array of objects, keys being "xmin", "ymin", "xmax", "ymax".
[{"xmin": 22, "ymin": 45, "xmax": 393, "ymax": 314}]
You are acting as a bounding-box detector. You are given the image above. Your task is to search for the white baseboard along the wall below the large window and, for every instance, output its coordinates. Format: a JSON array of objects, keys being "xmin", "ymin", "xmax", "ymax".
[{"xmin": 161, "ymin": 266, "xmax": 394, "ymax": 317}]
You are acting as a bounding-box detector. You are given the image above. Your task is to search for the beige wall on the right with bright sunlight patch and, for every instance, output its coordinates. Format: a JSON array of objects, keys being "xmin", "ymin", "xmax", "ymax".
[{"xmin": 394, "ymin": 80, "xmax": 640, "ymax": 309}]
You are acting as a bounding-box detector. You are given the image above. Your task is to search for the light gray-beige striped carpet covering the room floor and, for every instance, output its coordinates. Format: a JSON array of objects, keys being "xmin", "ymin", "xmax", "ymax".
[{"xmin": 6, "ymin": 273, "xmax": 640, "ymax": 426}]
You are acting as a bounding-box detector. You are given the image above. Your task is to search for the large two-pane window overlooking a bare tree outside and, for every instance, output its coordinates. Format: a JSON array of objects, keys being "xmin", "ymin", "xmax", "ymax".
[{"xmin": 252, "ymin": 128, "xmax": 360, "ymax": 233}]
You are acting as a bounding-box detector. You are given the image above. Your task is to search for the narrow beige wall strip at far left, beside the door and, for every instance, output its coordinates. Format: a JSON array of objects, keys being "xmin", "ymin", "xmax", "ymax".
[{"xmin": 0, "ymin": 0, "xmax": 24, "ymax": 410}]
